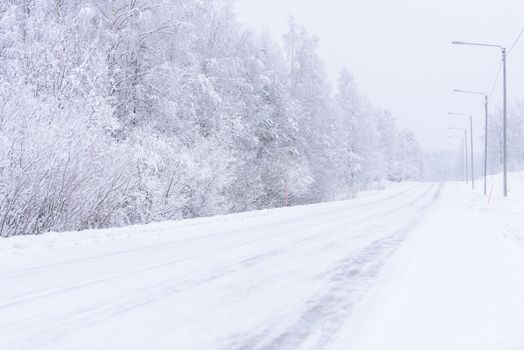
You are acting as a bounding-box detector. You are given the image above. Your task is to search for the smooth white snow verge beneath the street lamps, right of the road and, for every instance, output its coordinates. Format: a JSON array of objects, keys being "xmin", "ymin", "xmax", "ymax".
[{"xmin": 329, "ymin": 173, "xmax": 524, "ymax": 350}]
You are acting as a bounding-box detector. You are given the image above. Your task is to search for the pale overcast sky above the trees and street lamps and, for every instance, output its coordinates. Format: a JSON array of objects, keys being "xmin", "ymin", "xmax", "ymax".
[{"xmin": 236, "ymin": 0, "xmax": 524, "ymax": 150}]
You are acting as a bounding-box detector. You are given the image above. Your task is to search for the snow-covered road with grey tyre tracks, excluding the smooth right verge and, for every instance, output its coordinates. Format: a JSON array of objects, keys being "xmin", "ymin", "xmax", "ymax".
[{"xmin": 0, "ymin": 180, "xmax": 515, "ymax": 350}]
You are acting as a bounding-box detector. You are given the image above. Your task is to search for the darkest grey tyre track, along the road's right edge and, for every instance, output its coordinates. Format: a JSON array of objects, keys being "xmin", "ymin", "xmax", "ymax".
[{"xmin": 225, "ymin": 185, "xmax": 443, "ymax": 350}]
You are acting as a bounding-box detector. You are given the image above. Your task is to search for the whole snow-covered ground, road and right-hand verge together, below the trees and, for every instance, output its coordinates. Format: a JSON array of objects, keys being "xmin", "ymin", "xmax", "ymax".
[{"xmin": 0, "ymin": 174, "xmax": 524, "ymax": 350}]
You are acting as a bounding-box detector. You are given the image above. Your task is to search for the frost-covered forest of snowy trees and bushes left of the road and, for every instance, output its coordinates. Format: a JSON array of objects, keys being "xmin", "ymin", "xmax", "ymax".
[{"xmin": 0, "ymin": 0, "xmax": 424, "ymax": 237}]
